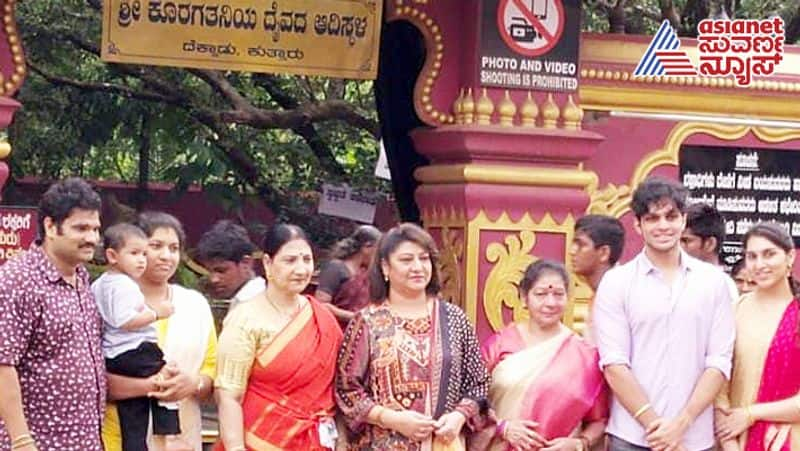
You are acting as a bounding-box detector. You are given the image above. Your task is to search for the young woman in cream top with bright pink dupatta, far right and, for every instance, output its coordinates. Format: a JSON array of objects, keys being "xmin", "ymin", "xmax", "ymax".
[{"xmin": 716, "ymin": 223, "xmax": 800, "ymax": 451}]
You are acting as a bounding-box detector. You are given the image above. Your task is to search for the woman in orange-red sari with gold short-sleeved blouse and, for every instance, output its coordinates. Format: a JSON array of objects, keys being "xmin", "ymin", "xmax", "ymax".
[{"xmin": 216, "ymin": 224, "xmax": 342, "ymax": 451}]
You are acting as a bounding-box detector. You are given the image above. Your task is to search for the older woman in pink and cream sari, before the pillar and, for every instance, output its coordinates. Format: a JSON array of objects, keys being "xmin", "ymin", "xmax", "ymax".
[{"xmin": 470, "ymin": 260, "xmax": 608, "ymax": 451}]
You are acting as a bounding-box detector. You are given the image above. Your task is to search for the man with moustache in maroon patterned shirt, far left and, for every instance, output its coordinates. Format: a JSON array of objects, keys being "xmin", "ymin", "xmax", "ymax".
[{"xmin": 0, "ymin": 178, "xmax": 106, "ymax": 451}]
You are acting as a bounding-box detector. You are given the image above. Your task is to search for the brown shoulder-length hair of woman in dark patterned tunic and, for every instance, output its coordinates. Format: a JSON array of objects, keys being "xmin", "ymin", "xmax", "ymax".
[{"xmin": 369, "ymin": 222, "xmax": 439, "ymax": 303}]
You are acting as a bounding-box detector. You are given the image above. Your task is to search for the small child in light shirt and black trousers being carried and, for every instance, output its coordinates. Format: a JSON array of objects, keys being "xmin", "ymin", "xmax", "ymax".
[{"xmin": 92, "ymin": 223, "xmax": 180, "ymax": 451}]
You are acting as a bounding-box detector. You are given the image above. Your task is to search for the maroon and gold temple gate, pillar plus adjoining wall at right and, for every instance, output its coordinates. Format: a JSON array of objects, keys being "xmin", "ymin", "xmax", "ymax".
[{"xmin": 378, "ymin": 0, "xmax": 800, "ymax": 337}]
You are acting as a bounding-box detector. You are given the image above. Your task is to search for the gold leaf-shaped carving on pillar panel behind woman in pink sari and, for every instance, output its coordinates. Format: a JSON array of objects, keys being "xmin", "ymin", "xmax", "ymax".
[{"xmin": 483, "ymin": 230, "xmax": 536, "ymax": 330}]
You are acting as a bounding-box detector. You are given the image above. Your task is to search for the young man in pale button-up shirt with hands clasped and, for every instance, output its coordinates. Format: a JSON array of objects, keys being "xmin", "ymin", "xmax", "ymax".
[{"xmin": 594, "ymin": 177, "xmax": 735, "ymax": 451}]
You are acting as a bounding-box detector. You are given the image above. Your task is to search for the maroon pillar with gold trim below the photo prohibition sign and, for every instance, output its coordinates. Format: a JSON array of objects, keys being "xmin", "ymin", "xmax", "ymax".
[{"xmin": 387, "ymin": 0, "xmax": 603, "ymax": 337}]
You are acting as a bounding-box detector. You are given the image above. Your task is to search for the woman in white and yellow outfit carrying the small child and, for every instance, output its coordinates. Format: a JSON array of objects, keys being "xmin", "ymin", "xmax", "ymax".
[{"xmin": 102, "ymin": 211, "xmax": 217, "ymax": 451}]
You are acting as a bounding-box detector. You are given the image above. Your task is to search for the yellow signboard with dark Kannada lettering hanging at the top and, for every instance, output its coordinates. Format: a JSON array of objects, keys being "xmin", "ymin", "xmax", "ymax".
[{"xmin": 102, "ymin": 0, "xmax": 383, "ymax": 79}]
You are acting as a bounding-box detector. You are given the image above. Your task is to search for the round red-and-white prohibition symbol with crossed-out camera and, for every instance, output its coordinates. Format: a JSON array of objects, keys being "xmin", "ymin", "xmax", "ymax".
[{"xmin": 497, "ymin": 0, "xmax": 566, "ymax": 57}]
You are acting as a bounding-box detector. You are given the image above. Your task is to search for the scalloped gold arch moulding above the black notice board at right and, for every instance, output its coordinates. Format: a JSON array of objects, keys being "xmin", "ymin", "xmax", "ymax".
[{"xmin": 587, "ymin": 122, "xmax": 800, "ymax": 218}]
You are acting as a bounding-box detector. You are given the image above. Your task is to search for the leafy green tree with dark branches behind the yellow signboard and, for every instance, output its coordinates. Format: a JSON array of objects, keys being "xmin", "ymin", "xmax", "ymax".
[{"xmin": 9, "ymin": 0, "xmax": 389, "ymax": 244}]
